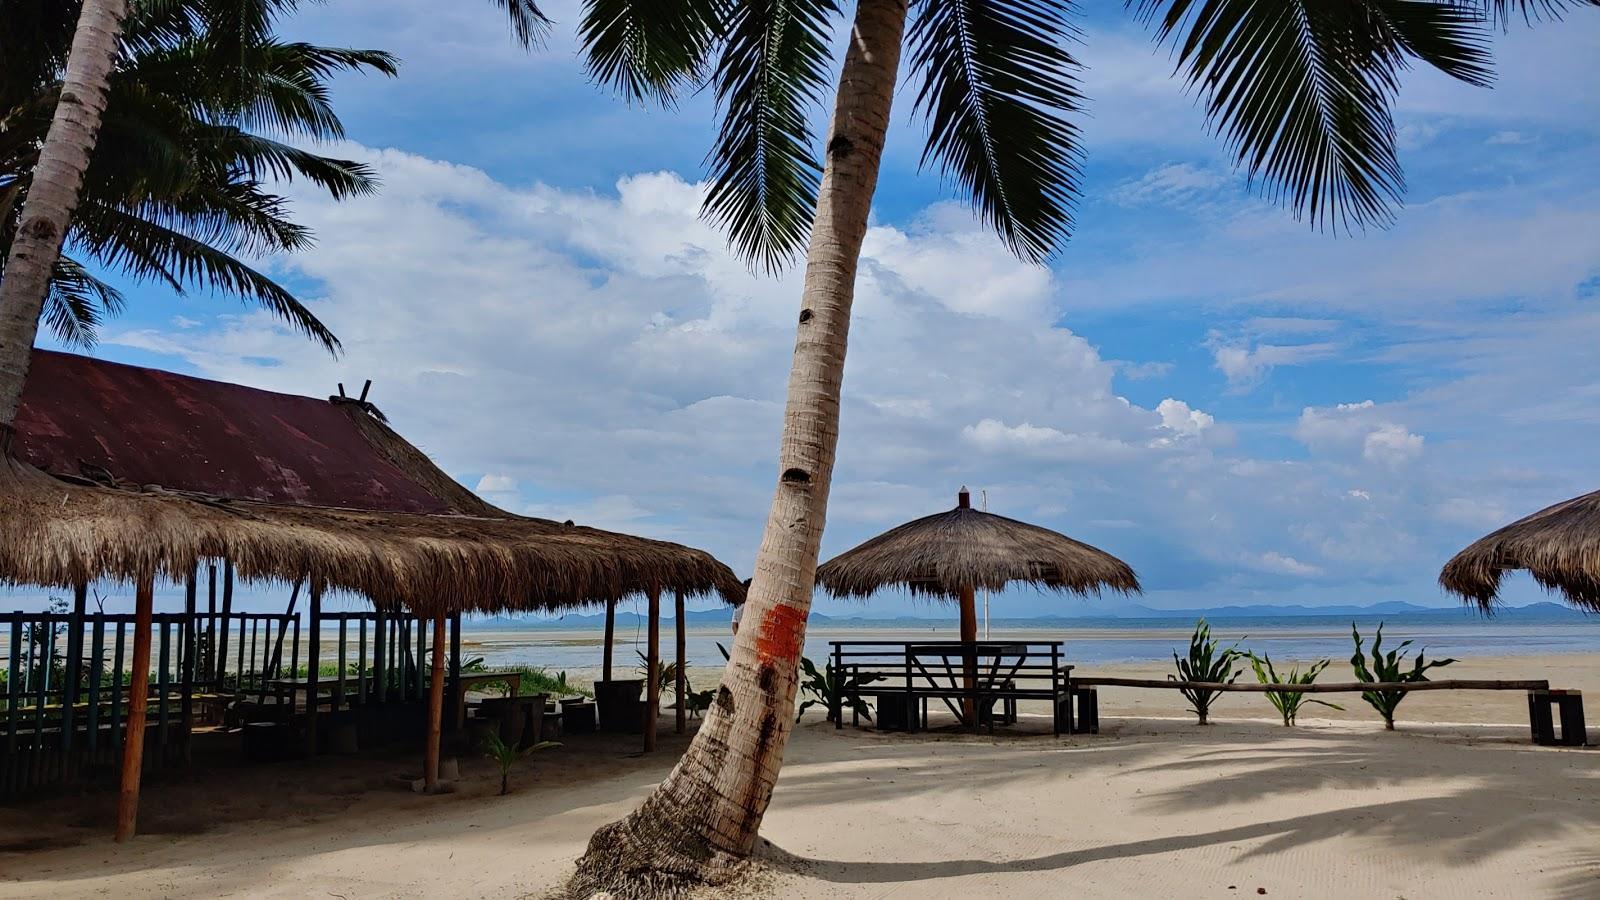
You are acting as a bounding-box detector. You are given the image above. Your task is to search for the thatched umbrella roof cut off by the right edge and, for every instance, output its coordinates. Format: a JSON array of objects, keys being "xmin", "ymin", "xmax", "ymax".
[{"xmin": 1438, "ymin": 490, "xmax": 1600, "ymax": 612}]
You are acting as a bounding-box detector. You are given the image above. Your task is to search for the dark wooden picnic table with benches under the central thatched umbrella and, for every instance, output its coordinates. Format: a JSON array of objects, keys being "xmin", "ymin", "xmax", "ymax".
[{"xmin": 829, "ymin": 641, "xmax": 1072, "ymax": 735}]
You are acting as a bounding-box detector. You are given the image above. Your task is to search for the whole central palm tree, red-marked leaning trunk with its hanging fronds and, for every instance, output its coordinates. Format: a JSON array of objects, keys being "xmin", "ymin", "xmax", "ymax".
[{"xmin": 568, "ymin": 0, "xmax": 1600, "ymax": 897}]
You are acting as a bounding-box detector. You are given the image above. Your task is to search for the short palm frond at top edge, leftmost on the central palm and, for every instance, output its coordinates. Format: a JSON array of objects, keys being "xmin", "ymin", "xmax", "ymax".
[{"xmin": 578, "ymin": 0, "xmax": 722, "ymax": 106}]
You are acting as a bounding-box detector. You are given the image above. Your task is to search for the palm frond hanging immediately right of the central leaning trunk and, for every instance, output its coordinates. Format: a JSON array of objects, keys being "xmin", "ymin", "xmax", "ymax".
[{"xmin": 909, "ymin": 0, "xmax": 1083, "ymax": 263}]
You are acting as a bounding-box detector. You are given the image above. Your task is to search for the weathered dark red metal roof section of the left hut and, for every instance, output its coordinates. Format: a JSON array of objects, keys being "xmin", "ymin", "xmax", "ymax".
[{"xmin": 14, "ymin": 351, "xmax": 453, "ymax": 512}]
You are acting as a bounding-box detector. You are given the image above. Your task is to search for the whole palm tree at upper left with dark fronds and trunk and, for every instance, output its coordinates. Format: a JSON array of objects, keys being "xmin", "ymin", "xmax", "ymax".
[{"xmin": 0, "ymin": 0, "xmax": 549, "ymax": 442}]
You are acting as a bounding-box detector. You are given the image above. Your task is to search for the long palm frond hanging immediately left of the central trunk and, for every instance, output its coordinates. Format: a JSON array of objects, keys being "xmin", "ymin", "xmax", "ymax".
[{"xmin": 704, "ymin": 0, "xmax": 838, "ymax": 271}]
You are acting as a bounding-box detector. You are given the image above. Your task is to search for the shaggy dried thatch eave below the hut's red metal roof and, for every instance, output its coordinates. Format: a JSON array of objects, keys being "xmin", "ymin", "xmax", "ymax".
[{"xmin": 0, "ymin": 460, "xmax": 744, "ymax": 615}]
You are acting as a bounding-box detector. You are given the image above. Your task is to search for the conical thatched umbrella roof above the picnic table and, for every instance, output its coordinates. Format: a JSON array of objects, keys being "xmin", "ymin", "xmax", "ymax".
[{"xmin": 816, "ymin": 488, "xmax": 1139, "ymax": 599}]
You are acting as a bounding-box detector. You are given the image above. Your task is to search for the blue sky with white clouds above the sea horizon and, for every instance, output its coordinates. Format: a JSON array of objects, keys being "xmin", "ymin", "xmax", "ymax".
[{"xmin": 21, "ymin": 0, "xmax": 1600, "ymax": 615}]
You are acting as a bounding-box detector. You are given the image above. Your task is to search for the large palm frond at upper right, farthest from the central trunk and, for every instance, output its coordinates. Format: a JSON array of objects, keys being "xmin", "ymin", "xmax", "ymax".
[{"xmin": 1130, "ymin": 0, "xmax": 1488, "ymax": 231}]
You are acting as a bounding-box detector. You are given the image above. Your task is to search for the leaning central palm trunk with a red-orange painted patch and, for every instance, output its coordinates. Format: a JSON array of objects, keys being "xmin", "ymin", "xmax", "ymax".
[{"xmin": 568, "ymin": 0, "xmax": 906, "ymax": 883}]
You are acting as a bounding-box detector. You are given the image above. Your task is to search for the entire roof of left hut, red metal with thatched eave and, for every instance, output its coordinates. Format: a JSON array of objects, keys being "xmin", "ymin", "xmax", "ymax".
[{"xmin": 0, "ymin": 354, "xmax": 744, "ymax": 613}]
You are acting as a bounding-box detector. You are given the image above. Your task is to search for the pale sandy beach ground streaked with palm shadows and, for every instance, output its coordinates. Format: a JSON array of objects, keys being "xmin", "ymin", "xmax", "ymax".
[{"xmin": 0, "ymin": 655, "xmax": 1600, "ymax": 900}]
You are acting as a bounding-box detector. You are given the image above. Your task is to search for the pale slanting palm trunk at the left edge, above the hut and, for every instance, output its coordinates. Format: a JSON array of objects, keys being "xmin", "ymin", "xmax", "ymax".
[{"xmin": 0, "ymin": 0, "xmax": 128, "ymax": 438}]
